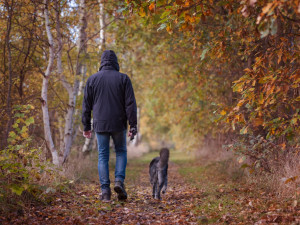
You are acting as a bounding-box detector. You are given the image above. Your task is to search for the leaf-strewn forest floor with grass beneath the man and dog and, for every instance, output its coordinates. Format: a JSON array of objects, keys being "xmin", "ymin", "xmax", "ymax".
[{"xmin": 0, "ymin": 149, "xmax": 300, "ymax": 224}]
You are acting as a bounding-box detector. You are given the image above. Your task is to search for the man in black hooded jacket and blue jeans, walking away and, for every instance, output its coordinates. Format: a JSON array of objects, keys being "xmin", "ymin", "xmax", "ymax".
[{"xmin": 82, "ymin": 50, "xmax": 137, "ymax": 201}]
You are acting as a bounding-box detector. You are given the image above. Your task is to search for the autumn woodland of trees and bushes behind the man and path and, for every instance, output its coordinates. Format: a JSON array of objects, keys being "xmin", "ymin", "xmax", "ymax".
[{"xmin": 0, "ymin": 0, "xmax": 300, "ymax": 218}]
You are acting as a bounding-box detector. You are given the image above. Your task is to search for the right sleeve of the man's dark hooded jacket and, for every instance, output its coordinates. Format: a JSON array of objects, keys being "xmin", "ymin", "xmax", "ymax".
[{"xmin": 125, "ymin": 76, "xmax": 137, "ymax": 127}]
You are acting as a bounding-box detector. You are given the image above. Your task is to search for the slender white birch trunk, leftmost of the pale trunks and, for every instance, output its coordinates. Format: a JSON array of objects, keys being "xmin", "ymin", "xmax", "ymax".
[{"xmin": 41, "ymin": 0, "xmax": 59, "ymax": 165}]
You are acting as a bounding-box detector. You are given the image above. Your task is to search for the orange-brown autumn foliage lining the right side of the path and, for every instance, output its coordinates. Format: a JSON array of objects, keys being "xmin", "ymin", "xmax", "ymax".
[{"xmin": 123, "ymin": 0, "xmax": 300, "ymax": 172}]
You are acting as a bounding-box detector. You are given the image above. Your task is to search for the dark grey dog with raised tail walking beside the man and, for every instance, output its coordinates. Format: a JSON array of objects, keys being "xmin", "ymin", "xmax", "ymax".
[{"xmin": 149, "ymin": 148, "xmax": 170, "ymax": 200}]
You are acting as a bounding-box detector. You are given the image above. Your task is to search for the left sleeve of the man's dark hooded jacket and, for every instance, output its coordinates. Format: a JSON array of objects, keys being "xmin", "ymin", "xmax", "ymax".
[{"xmin": 81, "ymin": 80, "xmax": 93, "ymax": 131}]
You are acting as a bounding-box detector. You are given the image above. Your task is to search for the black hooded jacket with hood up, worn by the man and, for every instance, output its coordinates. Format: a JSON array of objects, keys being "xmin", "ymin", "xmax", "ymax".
[{"xmin": 82, "ymin": 50, "xmax": 137, "ymax": 132}]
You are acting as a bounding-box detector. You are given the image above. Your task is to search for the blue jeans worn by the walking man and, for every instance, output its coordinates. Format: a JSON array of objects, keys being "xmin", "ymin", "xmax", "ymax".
[{"xmin": 96, "ymin": 130, "xmax": 127, "ymax": 192}]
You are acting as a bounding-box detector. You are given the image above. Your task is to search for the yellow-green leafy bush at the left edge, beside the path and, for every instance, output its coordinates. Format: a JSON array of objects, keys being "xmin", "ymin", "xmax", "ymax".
[{"xmin": 0, "ymin": 105, "xmax": 52, "ymax": 211}]
